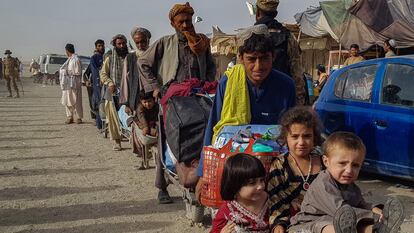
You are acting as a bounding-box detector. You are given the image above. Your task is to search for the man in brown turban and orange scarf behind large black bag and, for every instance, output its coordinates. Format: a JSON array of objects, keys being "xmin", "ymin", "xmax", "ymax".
[{"xmin": 138, "ymin": 2, "xmax": 216, "ymax": 204}]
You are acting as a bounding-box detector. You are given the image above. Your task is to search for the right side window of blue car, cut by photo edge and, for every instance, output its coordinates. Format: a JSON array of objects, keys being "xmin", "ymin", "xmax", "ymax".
[{"xmin": 381, "ymin": 64, "xmax": 414, "ymax": 107}]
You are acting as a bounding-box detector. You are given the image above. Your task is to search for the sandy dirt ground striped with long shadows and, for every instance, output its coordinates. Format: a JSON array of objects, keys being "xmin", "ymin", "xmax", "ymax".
[{"xmin": 0, "ymin": 78, "xmax": 414, "ymax": 233}]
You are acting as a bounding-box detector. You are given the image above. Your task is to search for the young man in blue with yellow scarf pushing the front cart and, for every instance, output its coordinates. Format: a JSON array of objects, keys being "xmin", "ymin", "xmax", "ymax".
[{"xmin": 196, "ymin": 24, "xmax": 295, "ymax": 204}]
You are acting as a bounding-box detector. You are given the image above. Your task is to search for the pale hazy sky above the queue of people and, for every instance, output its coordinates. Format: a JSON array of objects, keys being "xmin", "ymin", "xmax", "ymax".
[{"xmin": 0, "ymin": 0, "xmax": 319, "ymax": 60}]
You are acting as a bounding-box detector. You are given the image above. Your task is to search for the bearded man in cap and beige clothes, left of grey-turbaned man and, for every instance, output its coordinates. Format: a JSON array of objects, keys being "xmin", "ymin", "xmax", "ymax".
[{"xmin": 100, "ymin": 34, "xmax": 128, "ymax": 151}]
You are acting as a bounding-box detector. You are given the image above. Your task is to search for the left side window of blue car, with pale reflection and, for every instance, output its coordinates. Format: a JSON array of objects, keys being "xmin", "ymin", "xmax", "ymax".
[{"xmin": 342, "ymin": 65, "xmax": 378, "ymax": 101}]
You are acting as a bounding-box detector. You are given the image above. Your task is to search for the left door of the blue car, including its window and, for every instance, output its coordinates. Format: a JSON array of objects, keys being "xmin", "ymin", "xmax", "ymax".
[{"xmin": 316, "ymin": 64, "xmax": 379, "ymax": 144}]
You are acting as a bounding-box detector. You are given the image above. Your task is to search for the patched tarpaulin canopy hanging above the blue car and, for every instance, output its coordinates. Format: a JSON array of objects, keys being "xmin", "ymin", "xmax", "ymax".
[{"xmin": 295, "ymin": 0, "xmax": 414, "ymax": 50}]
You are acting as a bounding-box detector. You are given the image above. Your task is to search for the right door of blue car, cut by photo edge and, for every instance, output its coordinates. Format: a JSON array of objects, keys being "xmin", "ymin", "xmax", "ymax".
[{"xmin": 367, "ymin": 59, "xmax": 414, "ymax": 177}]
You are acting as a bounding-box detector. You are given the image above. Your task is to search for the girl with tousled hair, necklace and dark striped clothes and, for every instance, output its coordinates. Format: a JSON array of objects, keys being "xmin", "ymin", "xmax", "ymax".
[{"xmin": 267, "ymin": 107, "xmax": 323, "ymax": 233}]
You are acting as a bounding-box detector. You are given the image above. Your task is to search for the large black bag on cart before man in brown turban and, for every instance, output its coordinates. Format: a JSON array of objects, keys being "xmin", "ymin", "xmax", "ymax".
[{"xmin": 165, "ymin": 95, "xmax": 212, "ymax": 164}]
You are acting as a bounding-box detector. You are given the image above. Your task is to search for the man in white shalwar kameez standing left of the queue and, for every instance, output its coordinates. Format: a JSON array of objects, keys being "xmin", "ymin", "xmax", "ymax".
[{"xmin": 60, "ymin": 44, "xmax": 83, "ymax": 124}]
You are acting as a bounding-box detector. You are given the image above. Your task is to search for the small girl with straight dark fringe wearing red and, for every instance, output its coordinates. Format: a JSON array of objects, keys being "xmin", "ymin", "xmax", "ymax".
[{"xmin": 211, "ymin": 153, "xmax": 269, "ymax": 233}]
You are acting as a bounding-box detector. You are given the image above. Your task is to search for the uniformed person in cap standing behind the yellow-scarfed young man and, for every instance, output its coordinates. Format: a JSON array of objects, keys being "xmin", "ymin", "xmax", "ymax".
[{"xmin": 255, "ymin": 0, "xmax": 306, "ymax": 105}]
